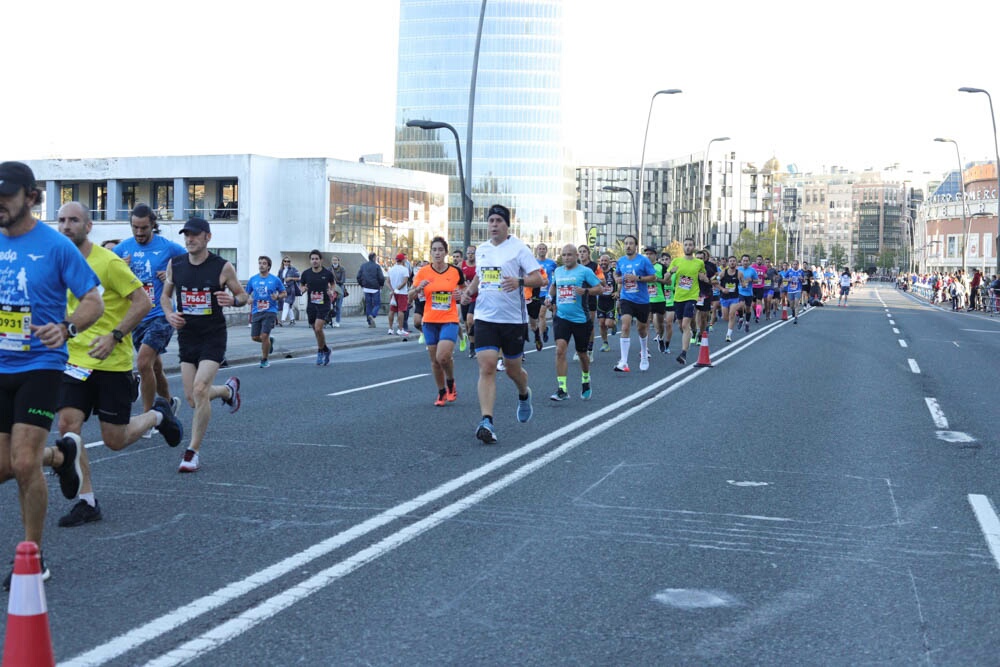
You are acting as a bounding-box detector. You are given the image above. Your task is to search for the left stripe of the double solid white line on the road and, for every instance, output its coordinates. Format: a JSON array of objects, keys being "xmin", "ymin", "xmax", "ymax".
[{"xmin": 60, "ymin": 320, "xmax": 791, "ymax": 667}]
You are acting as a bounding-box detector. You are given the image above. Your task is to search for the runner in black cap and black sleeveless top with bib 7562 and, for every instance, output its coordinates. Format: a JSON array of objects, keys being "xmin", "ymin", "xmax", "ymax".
[{"xmin": 160, "ymin": 217, "xmax": 248, "ymax": 472}]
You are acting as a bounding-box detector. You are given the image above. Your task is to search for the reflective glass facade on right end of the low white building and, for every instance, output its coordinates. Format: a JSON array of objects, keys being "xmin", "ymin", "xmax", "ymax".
[{"xmin": 328, "ymin": 181, "xmax": 446, "ymax": 261}]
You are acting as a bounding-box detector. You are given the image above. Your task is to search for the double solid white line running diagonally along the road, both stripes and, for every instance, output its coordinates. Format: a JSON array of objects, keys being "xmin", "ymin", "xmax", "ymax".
[{"xmin": 60, "ymin": 314, "xmax": 790, "ymax": 667}]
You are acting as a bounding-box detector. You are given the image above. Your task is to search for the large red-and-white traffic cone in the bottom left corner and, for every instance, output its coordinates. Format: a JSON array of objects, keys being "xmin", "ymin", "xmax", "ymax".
[{"xmin": 3, "ymin": 542, "xmax": 56, "ymax": 667}]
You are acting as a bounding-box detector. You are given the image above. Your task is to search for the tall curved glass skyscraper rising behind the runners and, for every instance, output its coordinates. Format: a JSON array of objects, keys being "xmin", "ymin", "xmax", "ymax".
[{"xmin": 394, "ymin": 0, "xmax": 584, "ymax": 248}]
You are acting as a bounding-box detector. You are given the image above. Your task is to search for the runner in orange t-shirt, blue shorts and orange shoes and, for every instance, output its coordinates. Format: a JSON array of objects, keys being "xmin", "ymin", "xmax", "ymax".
[{"xmin": 408, "ymin": 236, "xmax": 465, "ymax": 407}]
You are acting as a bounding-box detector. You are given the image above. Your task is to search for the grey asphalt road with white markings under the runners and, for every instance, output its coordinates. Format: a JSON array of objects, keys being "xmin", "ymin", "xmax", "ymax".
[{"xmin": 0, "ymin": 287, "xmax": 1000, "ymax": 666}]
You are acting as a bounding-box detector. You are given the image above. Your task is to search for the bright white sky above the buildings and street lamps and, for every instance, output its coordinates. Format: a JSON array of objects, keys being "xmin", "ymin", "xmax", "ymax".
[{"xmin": 7, "ymin": 0, "xmax": 1000, "ymax": 185}]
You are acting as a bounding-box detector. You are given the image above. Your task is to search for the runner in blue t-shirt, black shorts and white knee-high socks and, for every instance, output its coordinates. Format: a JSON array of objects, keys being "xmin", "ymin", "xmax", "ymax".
[{"xmin": 615, "ymin": 234, "xmax": 656, "ymax": 373}]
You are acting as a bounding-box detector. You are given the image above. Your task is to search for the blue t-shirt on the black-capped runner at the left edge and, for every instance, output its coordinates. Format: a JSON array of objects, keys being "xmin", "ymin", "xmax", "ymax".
[{"xmin": 0, "ymin": 222, "xmax": 100, "ymax": 373}]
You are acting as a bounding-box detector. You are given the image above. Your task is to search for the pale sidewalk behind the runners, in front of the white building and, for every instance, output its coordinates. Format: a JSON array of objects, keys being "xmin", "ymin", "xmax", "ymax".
[{"xmin": 163, "ymin": 313, "xmax": 406, "ymax": 373}]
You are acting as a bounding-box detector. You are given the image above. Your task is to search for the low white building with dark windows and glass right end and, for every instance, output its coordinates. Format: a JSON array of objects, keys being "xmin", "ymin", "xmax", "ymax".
[{"xmin": 18, "ymin": 154, "xmax": 448, "ymax": 279}]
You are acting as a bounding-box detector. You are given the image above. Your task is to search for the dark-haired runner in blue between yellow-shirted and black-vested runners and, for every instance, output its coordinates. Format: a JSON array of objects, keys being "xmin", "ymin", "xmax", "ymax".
[{"xmin": 114, "ymin": 204, "xmax": 185, "ymax": 422}]
